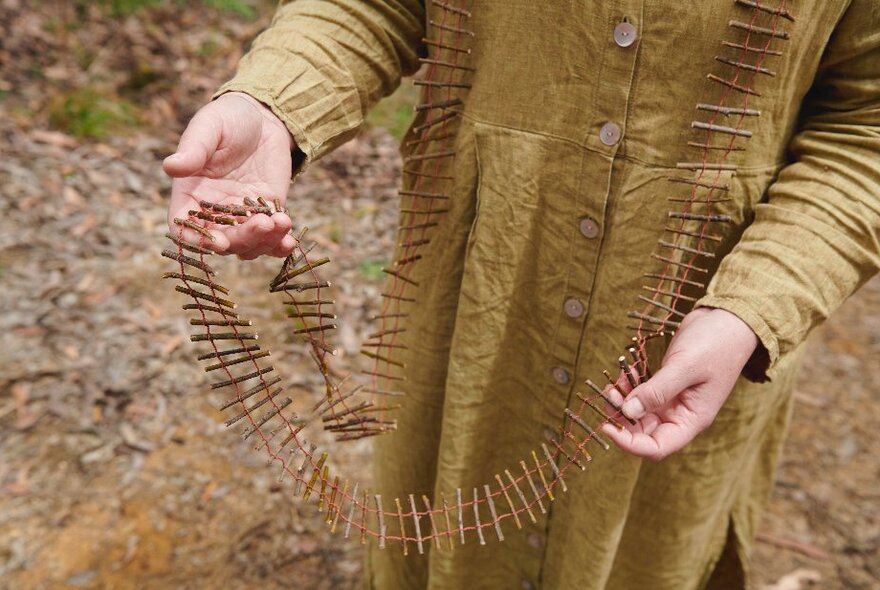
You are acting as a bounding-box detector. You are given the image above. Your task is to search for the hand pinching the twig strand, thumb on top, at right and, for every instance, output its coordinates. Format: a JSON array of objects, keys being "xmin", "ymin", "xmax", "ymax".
[{"xmin": 602, "ymin": 308, "xmax": 758, "ymax": 461}]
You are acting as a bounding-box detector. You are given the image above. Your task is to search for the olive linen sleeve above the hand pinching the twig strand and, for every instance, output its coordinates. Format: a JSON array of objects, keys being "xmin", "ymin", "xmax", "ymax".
[{"xmin": 698, "ymin": 0, "xmax": 880, "ymax": 381}]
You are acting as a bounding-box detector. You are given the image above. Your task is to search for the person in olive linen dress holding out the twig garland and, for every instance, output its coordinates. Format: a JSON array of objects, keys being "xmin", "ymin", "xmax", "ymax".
[{"xmin": 165, "ymin": 0, "xmax": 880, "ymax": 590}]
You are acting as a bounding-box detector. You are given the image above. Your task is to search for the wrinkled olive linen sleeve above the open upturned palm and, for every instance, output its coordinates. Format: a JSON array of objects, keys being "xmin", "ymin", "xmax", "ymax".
[{"xmin": 215, "ymin": 0, "xmax": 425, "ymax": 171}]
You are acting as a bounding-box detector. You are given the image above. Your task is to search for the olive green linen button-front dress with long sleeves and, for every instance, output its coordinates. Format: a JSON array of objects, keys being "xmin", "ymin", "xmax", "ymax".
[{"xmin": 220, "ymin": 0, "xmax": 880, "ymax": 590}]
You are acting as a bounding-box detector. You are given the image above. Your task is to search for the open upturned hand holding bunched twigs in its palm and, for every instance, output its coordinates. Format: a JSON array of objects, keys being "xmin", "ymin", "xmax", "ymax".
[{"xmin": 162, "ymin": 92, "xmax": 295, "ymax": 260}]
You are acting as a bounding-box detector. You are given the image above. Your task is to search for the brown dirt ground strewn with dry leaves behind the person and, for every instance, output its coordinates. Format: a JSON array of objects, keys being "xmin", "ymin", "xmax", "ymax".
[{"xmin": 0, "ymin": 0, "xmax": 880, "ymax": 590}]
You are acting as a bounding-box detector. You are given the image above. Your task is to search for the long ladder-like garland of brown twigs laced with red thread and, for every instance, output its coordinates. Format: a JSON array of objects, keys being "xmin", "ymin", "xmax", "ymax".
[{"xmin": 162, "ymin": 0, "xmax": 794, "ymax": 554}]
